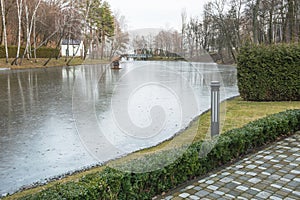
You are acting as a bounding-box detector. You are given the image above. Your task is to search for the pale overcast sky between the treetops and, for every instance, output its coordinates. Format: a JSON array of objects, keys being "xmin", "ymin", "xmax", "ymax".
[{"xmin": 107, "ymin": 0, "xmax": 209, "ymax": 30}]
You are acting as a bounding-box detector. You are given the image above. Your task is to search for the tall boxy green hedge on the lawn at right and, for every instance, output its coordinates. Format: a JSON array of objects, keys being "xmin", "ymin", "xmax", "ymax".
[{"xmin": 237, "ymin": 44, "xmax": 300, "ymax": 101}]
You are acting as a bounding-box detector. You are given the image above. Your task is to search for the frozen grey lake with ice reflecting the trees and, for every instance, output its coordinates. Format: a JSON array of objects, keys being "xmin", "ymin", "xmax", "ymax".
[{"xmin": 0, "ymin": 61, "xmax": 238, "ymax": 196}]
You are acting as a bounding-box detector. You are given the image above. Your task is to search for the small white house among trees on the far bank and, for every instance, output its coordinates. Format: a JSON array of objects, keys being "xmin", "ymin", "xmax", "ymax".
[{"xmin": 61, "ymin": 39, "xmax": 84, "ymax": 56}]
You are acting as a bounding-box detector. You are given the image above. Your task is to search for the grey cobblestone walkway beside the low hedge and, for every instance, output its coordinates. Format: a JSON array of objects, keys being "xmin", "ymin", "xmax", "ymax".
[{"xmin": 163, "ymin": 132, "xmax": 300, "ymax": 200}]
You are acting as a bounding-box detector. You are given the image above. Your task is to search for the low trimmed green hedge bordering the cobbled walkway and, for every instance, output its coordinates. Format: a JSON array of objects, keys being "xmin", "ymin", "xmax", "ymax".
[{"xmin": 18, "ymin": 110, "xmax": 300, "ymax": 199}]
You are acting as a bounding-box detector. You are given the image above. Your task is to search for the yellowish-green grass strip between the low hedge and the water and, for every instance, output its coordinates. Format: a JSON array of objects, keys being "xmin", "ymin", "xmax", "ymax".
[{"xmin": 5, "ymin": 97, "xmax": 300, "ymax": 199}]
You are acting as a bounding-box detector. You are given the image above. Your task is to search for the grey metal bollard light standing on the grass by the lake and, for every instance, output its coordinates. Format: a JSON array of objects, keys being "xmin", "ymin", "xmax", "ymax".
[{"xmin": 210, "ymin": 81, "xmax": 220, "ymax": 138}]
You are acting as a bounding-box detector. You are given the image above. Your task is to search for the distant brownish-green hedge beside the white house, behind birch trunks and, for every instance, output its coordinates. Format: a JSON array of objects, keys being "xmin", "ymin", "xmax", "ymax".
[{"xmin": 0, "ymin": 46, "xmax": 59, "ymax": 58}]
